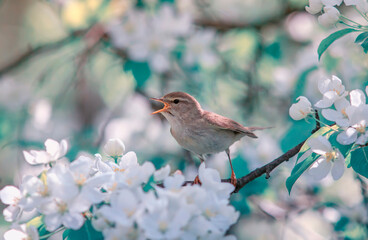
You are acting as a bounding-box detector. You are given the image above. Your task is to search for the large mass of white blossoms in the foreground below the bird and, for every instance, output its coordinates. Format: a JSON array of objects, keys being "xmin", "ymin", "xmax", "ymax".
[{"xmin": 0, "ymin": 139, "xmax": 239, "ymax": 240}]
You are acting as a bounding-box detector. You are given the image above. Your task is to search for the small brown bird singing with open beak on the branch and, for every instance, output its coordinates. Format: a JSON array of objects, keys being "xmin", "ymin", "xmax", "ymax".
[{"xmin": 151, "ymin": 92, "xmax": 265, "ymax": 186}]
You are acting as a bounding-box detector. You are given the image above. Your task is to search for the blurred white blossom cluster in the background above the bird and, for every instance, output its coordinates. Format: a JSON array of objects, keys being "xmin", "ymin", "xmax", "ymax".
[{"xmin": 106, "ymin": 4, "xmax": 218, "ymax": 73}]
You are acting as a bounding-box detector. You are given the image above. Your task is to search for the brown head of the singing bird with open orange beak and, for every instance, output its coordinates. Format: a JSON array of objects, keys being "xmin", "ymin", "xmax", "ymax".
[{"xmin": 151, "ymin": 92, "xmax": 202, "ymax": 121}]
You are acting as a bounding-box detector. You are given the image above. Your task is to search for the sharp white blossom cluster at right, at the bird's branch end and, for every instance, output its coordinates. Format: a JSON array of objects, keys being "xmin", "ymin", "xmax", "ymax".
[{"xmin": 289, "ymin": 76, "xmax": 368, "ymax": 180}]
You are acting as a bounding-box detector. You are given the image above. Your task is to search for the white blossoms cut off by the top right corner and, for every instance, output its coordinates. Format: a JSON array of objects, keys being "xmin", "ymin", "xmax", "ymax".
[{"xmin": 305, "ymin": 0, "xmax": 368, "ymax": 27}]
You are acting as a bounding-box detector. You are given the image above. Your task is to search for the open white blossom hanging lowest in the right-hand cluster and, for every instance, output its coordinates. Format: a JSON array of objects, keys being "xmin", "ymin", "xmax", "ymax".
[{"xmin": 308, "ymin": 136, "xmax": 345, "ymax": 180}]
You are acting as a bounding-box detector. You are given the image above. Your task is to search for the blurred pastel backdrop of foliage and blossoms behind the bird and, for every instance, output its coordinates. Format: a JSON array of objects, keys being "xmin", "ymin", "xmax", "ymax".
[{"xmin": 0, "ymin": 0, "xmax": 368, "ymax": 240}]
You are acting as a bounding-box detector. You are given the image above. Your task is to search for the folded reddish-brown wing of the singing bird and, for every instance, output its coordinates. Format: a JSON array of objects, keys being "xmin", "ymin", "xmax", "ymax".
[{"xmin": 203, "ymin": 111, "xmax": 261, "ymax": 138}]
